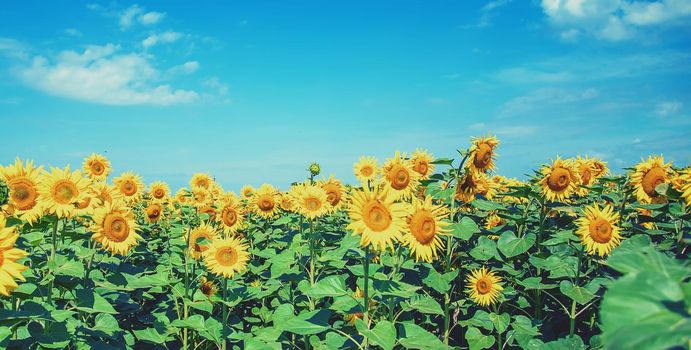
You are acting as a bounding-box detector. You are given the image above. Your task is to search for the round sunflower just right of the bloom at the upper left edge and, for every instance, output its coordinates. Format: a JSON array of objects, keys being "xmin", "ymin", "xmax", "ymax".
[{"xmin": 38, "ymin": 166, "xmax": 89, "ymax": 218}]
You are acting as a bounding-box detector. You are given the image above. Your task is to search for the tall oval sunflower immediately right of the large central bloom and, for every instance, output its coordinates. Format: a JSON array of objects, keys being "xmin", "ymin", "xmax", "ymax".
[{"xmin": 403, "ymin": 197, "xmax": 449, "ymax": 263}]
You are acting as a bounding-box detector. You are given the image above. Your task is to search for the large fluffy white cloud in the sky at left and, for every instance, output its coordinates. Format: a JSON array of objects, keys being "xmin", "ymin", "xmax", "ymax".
[{"xmin": 16, "ymin": 44, "xmax": 199, "ymax": 105}]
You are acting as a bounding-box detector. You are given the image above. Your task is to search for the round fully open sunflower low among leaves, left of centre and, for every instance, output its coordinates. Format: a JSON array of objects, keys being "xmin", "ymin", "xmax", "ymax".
[{"xmin": 203, "ymin": 237, "xmax": 249, "ymax": 278}]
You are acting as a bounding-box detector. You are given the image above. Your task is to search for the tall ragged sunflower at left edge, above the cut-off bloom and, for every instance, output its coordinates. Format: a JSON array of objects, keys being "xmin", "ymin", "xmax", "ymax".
[{"xmin": 0, "ymin": 158, "xmax": 43, "ymax": 223}]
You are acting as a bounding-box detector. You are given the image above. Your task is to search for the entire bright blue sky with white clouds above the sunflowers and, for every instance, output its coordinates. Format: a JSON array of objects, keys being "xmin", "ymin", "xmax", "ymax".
[{"xmin": 0, "ymin": 0, "xmax": 691, "ymax": 190}]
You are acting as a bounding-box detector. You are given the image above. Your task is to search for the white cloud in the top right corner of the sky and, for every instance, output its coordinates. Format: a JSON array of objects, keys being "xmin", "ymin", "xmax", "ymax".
[{"xmin": 542, "ymin": 0, "xmax": 691, "ymax": 41}]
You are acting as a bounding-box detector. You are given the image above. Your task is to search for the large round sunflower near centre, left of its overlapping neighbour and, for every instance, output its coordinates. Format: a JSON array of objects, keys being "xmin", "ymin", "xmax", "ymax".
[{"xmin": 347, "ymin": 187, "xmax": 409, "ymax": 251}]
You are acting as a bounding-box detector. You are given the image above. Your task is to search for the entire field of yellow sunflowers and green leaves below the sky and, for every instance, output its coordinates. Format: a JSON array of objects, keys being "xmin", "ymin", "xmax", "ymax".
[{"xmin": 0, "ymin": 136, "xmax": 691, "ymax": 350}]
